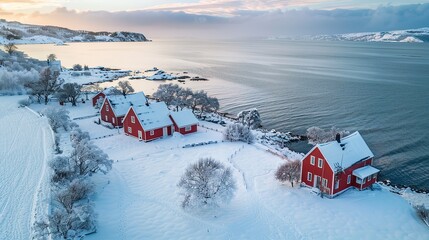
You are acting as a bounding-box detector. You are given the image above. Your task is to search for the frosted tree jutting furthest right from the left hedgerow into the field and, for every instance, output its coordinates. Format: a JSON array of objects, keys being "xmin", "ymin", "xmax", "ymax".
[{"xmin": 70, "ymin": 139, "xmax": 113, "ymax": 176}]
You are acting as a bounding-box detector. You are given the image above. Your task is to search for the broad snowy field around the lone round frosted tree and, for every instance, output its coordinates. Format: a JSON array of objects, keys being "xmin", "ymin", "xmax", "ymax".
[{"xmin": 28, "ymin": 103, "xmax": 429, "ymax": 239}]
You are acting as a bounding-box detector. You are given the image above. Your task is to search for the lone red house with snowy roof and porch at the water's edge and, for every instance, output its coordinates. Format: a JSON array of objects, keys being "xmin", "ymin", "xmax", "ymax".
[{"xmin": 301, "ymin": 132, "xmax": 380, "ymax": 197}]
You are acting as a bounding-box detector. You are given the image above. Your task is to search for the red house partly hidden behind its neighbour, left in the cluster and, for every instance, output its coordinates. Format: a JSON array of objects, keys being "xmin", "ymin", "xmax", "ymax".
[{"xmin": 100, "ymin": 92, "xmax": 146, "ymax": 127}]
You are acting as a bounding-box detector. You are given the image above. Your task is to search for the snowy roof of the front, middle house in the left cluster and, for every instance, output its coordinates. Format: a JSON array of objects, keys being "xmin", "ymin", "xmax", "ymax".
[{"xmin": 133, "ymin": 102, "xmax": 173, "ymax": 131}]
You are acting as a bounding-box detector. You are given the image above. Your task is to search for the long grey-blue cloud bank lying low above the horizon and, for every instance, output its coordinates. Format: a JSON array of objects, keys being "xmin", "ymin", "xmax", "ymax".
[{"xmin": 5, "ymin": 1, "xmax": 429, "ymax": 38}]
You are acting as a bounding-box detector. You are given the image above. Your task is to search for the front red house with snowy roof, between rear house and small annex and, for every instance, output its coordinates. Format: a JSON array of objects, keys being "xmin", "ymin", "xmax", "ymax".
[{"xmin": 124, "ymin": 102, "xmax": 174, "ymax": 142}]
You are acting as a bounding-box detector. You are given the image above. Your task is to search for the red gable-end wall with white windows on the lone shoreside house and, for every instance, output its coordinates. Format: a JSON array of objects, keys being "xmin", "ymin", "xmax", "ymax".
[{"xmin": 301, "ymin": 147, "xmax": 334, "ymax": 194}]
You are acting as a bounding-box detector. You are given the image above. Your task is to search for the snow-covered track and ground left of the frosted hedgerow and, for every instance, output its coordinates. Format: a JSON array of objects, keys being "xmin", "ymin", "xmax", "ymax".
[{"xmin": 0, "ymin": 96, "xmax": 53, "ymax": 239}]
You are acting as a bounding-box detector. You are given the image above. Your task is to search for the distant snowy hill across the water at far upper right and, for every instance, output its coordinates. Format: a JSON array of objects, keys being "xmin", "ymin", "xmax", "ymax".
[{"xmin": 311, "ymin": 28, "xmax": 429, "ymax": 43}]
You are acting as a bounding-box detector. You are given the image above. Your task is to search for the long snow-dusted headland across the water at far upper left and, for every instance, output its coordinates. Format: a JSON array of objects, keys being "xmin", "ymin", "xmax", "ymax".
[{"xmin": 0, "ymin": 19, "xmax": 148, "ymax": 44}]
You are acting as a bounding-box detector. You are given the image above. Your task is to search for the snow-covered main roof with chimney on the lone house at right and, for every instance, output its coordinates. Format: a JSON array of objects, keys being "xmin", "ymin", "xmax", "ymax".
[{"xmin": 317, "ymin": 132, "xmax": 374, "ymax": 170}]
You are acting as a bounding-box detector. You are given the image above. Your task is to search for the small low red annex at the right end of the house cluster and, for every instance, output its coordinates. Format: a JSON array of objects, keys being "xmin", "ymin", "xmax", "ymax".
[{"xmin": 170, "ymin": 109, "xmax": 198, "ymax": 134}]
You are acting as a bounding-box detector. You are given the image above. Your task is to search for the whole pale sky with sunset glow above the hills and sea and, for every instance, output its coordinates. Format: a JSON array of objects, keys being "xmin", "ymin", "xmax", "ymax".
[{"xmin": 0, "ymin": 0, "xmax": 429, "ymax": 38}]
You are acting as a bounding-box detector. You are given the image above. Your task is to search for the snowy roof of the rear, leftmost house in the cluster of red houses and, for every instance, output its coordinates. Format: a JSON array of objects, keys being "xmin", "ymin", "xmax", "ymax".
[{"xmin": 106, "ymin": 92, "xmax": 146, "ymax": 117}]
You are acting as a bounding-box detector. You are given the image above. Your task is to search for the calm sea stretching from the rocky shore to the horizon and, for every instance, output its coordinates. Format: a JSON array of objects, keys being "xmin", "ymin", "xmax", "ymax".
[{"xmin": 19, "ymin": 40, "xmax": 429, "ymax": 189}]
